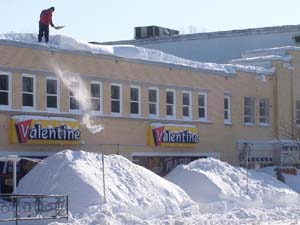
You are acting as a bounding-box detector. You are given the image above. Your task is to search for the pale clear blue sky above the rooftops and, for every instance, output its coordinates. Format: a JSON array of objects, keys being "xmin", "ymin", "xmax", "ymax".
[{"xmin": 0, "ymin": 0, "xmax": 300, "ymax": 42}]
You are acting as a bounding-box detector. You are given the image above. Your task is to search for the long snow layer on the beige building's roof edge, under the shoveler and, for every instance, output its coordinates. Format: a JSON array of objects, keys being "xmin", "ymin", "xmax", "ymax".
[{"xmin": 0, "ymin": 33, "xmax": 274, "ymax": 74}]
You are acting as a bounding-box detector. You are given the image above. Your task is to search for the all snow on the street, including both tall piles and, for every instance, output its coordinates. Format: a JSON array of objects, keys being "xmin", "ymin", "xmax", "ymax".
[{"xmin": 12, "ymin": 150, "xmax": 300, "ymax": 225}]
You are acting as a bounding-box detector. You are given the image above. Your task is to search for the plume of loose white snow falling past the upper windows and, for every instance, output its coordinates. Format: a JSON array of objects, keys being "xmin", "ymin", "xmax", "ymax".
[{"xmin": 54, "ymin": 66, "xmax": 104, "ymax": 134}]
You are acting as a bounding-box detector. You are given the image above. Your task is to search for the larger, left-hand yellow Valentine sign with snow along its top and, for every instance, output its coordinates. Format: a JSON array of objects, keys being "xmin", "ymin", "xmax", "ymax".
[{"xmin": 9, "ymin": 115, "xmax": 81, "ymax": 145}]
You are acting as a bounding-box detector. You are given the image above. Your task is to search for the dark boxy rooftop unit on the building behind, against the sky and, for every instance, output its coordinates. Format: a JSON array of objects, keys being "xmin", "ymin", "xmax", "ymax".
[{"xmin": 134, "ymin": 26, "xmax": 179, "ymax": 39}]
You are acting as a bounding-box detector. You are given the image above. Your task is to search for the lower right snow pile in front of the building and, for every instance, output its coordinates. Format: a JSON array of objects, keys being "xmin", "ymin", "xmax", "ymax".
[{"xmin": 166, "ymin": 158, "xmax": 300, "ymax": 212}]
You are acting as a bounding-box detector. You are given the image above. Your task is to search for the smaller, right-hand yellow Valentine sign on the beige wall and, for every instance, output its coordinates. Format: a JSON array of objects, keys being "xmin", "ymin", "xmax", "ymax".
[{"xmin": 148, "ymin": 123, "xmax": 199, "ymax": 147}]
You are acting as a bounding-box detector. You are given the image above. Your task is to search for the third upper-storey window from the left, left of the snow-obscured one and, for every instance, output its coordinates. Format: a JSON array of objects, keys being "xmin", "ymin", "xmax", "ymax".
[{"xmin": 46, "ymin": 78, "xmax": 59, "ymax": 110}]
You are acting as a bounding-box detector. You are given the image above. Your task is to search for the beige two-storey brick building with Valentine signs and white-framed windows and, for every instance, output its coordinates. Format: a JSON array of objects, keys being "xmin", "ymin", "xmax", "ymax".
[{"xmin": 0, "ymin": 39, "xmax": 300, "ymax": 192}]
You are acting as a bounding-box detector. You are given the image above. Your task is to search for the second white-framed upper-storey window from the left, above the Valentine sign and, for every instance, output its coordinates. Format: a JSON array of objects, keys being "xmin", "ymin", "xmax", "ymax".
[{"xmin": 22, "ymin": 75, "xmax": 35, "ymax": 108}]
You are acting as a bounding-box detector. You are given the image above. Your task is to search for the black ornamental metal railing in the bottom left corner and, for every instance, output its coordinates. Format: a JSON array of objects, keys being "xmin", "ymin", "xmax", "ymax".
[{"xmin": 0, "ymin": 195, "xmax": 69, "ymax": 225}]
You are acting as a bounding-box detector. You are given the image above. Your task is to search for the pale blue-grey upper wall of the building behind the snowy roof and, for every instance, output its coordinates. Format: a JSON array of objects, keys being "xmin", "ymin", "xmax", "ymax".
[{"xmin": 96, "ymin": 25, "xmax": 300, "ymax": 63}]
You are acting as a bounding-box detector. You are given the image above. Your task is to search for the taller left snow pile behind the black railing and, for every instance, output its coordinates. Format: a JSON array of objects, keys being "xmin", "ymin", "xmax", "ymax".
[{"xmin": 17, "ymin": 150, "xmax": 198, "ymax": 221}]
